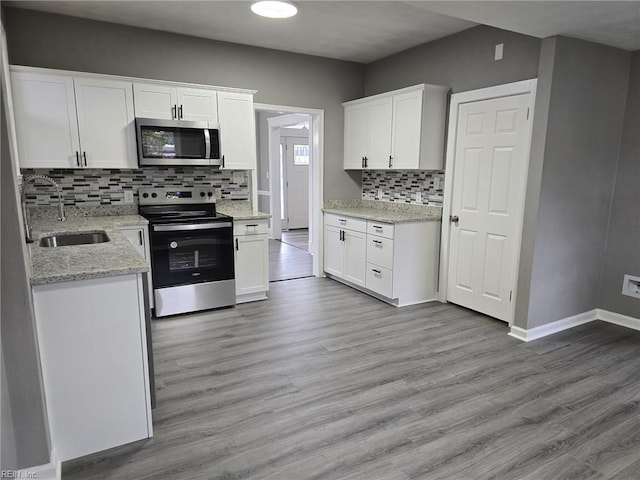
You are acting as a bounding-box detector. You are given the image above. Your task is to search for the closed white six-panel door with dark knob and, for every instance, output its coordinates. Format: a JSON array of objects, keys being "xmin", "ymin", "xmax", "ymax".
[{"xmin": 443, "ymin": 93, "xmax": 532, "ymax": 321}]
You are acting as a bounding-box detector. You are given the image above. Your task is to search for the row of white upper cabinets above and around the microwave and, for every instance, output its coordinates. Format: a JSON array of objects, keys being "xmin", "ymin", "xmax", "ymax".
[{"xmin": 10, "ymin": 66, "xmax": 256, "ymax": 170}]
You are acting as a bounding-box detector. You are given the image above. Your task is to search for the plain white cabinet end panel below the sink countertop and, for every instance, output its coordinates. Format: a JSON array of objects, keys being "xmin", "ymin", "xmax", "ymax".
[{"xmin": 33, "ymin": 274, "xmax": 153, "ymax": 461}]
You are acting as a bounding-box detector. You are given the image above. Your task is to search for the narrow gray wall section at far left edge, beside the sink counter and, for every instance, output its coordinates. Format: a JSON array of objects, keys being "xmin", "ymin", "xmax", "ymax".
[{"xmin": 0, "ymin": 81, "xmax": 49, "ymax": 464}]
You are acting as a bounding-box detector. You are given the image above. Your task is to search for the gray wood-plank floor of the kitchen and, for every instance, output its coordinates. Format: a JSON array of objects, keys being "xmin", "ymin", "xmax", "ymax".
[{"xmin": 63, "ymin": 278, "xmax": 640, "ymax": 480}]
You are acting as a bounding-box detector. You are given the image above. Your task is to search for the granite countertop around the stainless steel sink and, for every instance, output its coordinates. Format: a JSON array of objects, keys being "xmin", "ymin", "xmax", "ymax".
[{"xmin": 28, "ymin": 214, "xmax": 149, "ymax": 285}]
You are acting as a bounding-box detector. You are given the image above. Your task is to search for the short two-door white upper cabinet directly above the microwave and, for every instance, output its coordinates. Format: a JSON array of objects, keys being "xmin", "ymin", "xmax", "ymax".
[{"xmin": 133, "ymin": 83, "xmax": 218, "ymax": 124}]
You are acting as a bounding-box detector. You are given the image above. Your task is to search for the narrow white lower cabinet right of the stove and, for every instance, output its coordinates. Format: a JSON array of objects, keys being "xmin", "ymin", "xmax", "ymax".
[{"xmin": 233, "ymin": 219, "xmax": 269, "ymax": 303}]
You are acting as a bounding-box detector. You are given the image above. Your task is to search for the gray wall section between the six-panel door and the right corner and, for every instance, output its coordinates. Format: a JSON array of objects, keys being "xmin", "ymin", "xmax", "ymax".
[{"xmin": 516, "ymin": 37, "xmax": 630, "ymax": 328}]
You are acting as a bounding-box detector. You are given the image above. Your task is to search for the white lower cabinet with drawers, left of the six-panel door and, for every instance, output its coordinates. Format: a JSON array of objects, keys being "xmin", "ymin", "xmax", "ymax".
[{"xmin": 324, "ymin": 214, "xmax": 440, "ymax": 306}]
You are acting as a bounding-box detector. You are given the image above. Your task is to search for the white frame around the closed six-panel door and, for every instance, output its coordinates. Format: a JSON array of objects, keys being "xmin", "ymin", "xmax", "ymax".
[{"xmin": 438, "ymin": 78, "xmax": 538, "ymax": 326}]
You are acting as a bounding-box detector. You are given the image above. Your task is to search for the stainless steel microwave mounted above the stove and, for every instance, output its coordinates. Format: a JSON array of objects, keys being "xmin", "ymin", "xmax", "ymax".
[{"xmin": 136, "ymin": 118, "xmax": 222, "ymax": 167}]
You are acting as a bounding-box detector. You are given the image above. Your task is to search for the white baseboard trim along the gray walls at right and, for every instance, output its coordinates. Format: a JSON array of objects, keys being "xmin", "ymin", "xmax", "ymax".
[{"xmin": 509, "ymin": 308, "xmax": 640, "ymax": 342}]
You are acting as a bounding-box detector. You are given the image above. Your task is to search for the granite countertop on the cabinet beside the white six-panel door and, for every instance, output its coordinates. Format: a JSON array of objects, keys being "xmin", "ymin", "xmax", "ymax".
[{"xmin": 322, "ymin": 200, "xmax": 442, "ymax": 223}]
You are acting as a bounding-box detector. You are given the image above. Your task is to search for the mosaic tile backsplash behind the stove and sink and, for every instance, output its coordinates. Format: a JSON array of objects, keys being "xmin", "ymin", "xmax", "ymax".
[{"xmin": 22, "ymin": 167, "xmax": 249, "ymax": 207}]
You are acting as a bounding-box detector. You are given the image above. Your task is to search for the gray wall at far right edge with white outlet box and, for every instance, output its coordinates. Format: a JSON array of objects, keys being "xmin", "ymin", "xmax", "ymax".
[{"xmin": 599, "ymin": 51, "xmax": 640, "ymax": 318}]
